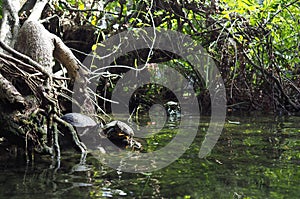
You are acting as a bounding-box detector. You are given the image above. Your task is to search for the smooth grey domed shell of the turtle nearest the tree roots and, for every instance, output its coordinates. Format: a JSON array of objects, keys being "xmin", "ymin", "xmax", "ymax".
[{"xmin": 61, "ymin": 113, "xmax": 97, "ymax": 127}]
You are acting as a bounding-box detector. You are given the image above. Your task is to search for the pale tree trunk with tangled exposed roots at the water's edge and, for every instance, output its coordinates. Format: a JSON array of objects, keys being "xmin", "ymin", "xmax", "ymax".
[{"xmin": 0, "ymin": 0, "xmax": 93, "ymax": 157}]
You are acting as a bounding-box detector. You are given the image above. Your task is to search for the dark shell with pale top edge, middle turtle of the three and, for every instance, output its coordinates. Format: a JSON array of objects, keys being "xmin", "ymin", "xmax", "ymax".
[{"xmin": 103, "ymin": 121, "xmax": 134, "ymax": 137}]
